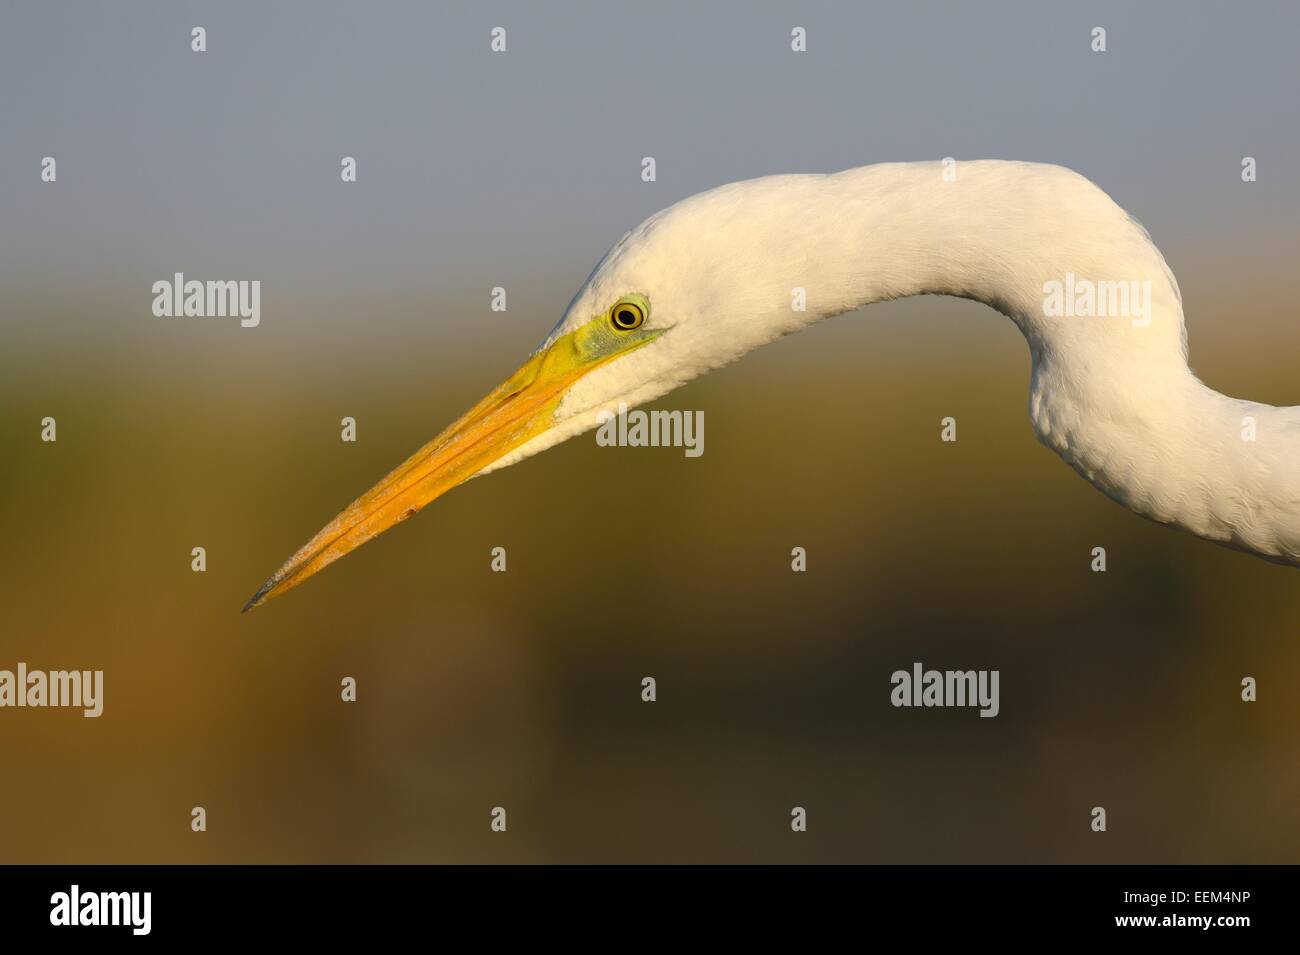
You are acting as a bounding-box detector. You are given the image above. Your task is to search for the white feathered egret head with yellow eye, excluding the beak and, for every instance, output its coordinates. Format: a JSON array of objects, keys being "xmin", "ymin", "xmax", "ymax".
[{"xmin": 484, "ymin": 177, "xmax": 810, "ymax": 470}]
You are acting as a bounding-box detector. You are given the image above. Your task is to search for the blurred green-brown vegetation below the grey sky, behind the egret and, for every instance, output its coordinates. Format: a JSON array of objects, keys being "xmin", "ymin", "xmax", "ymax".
[{"xmin": 0, "ymin": 285, "xmax": 1300, "ymax": 863}]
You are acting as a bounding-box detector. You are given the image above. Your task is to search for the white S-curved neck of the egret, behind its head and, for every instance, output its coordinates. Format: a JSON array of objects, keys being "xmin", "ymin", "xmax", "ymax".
[{"xmin": 818, "ymin": 162, "xmax": 1300, "ymax": 563}]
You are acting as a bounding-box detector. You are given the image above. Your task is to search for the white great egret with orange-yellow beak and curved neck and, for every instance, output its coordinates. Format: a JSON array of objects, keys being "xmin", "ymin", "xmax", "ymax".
[{"xmin": 244, "ymin": 161, "xmax": 1300, "ymax": 611}]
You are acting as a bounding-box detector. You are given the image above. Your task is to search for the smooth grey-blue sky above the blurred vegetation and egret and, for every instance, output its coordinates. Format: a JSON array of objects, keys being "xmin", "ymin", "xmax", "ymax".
[{"xmin": 0, "ymin": 1, "xmax": 1300, "ymax": 340}]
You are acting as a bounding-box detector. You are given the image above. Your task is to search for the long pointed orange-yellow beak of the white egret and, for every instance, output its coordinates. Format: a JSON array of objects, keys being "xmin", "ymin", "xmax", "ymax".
[{"xmin": 243, "ymin": 322, "xmax": 657, "ymax": 612}]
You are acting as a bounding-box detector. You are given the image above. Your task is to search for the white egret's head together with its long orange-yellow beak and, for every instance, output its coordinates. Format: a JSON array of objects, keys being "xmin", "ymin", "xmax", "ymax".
[{"xmin": 244, "ymin": 177, "xmax": 811, "ymax": 611}]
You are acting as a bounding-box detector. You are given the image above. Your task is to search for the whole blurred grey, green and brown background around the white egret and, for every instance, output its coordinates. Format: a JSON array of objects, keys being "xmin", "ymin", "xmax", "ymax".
[{"xmin": 0, "ymin": 3, "xmax": 1300, "ymax": 863}]
